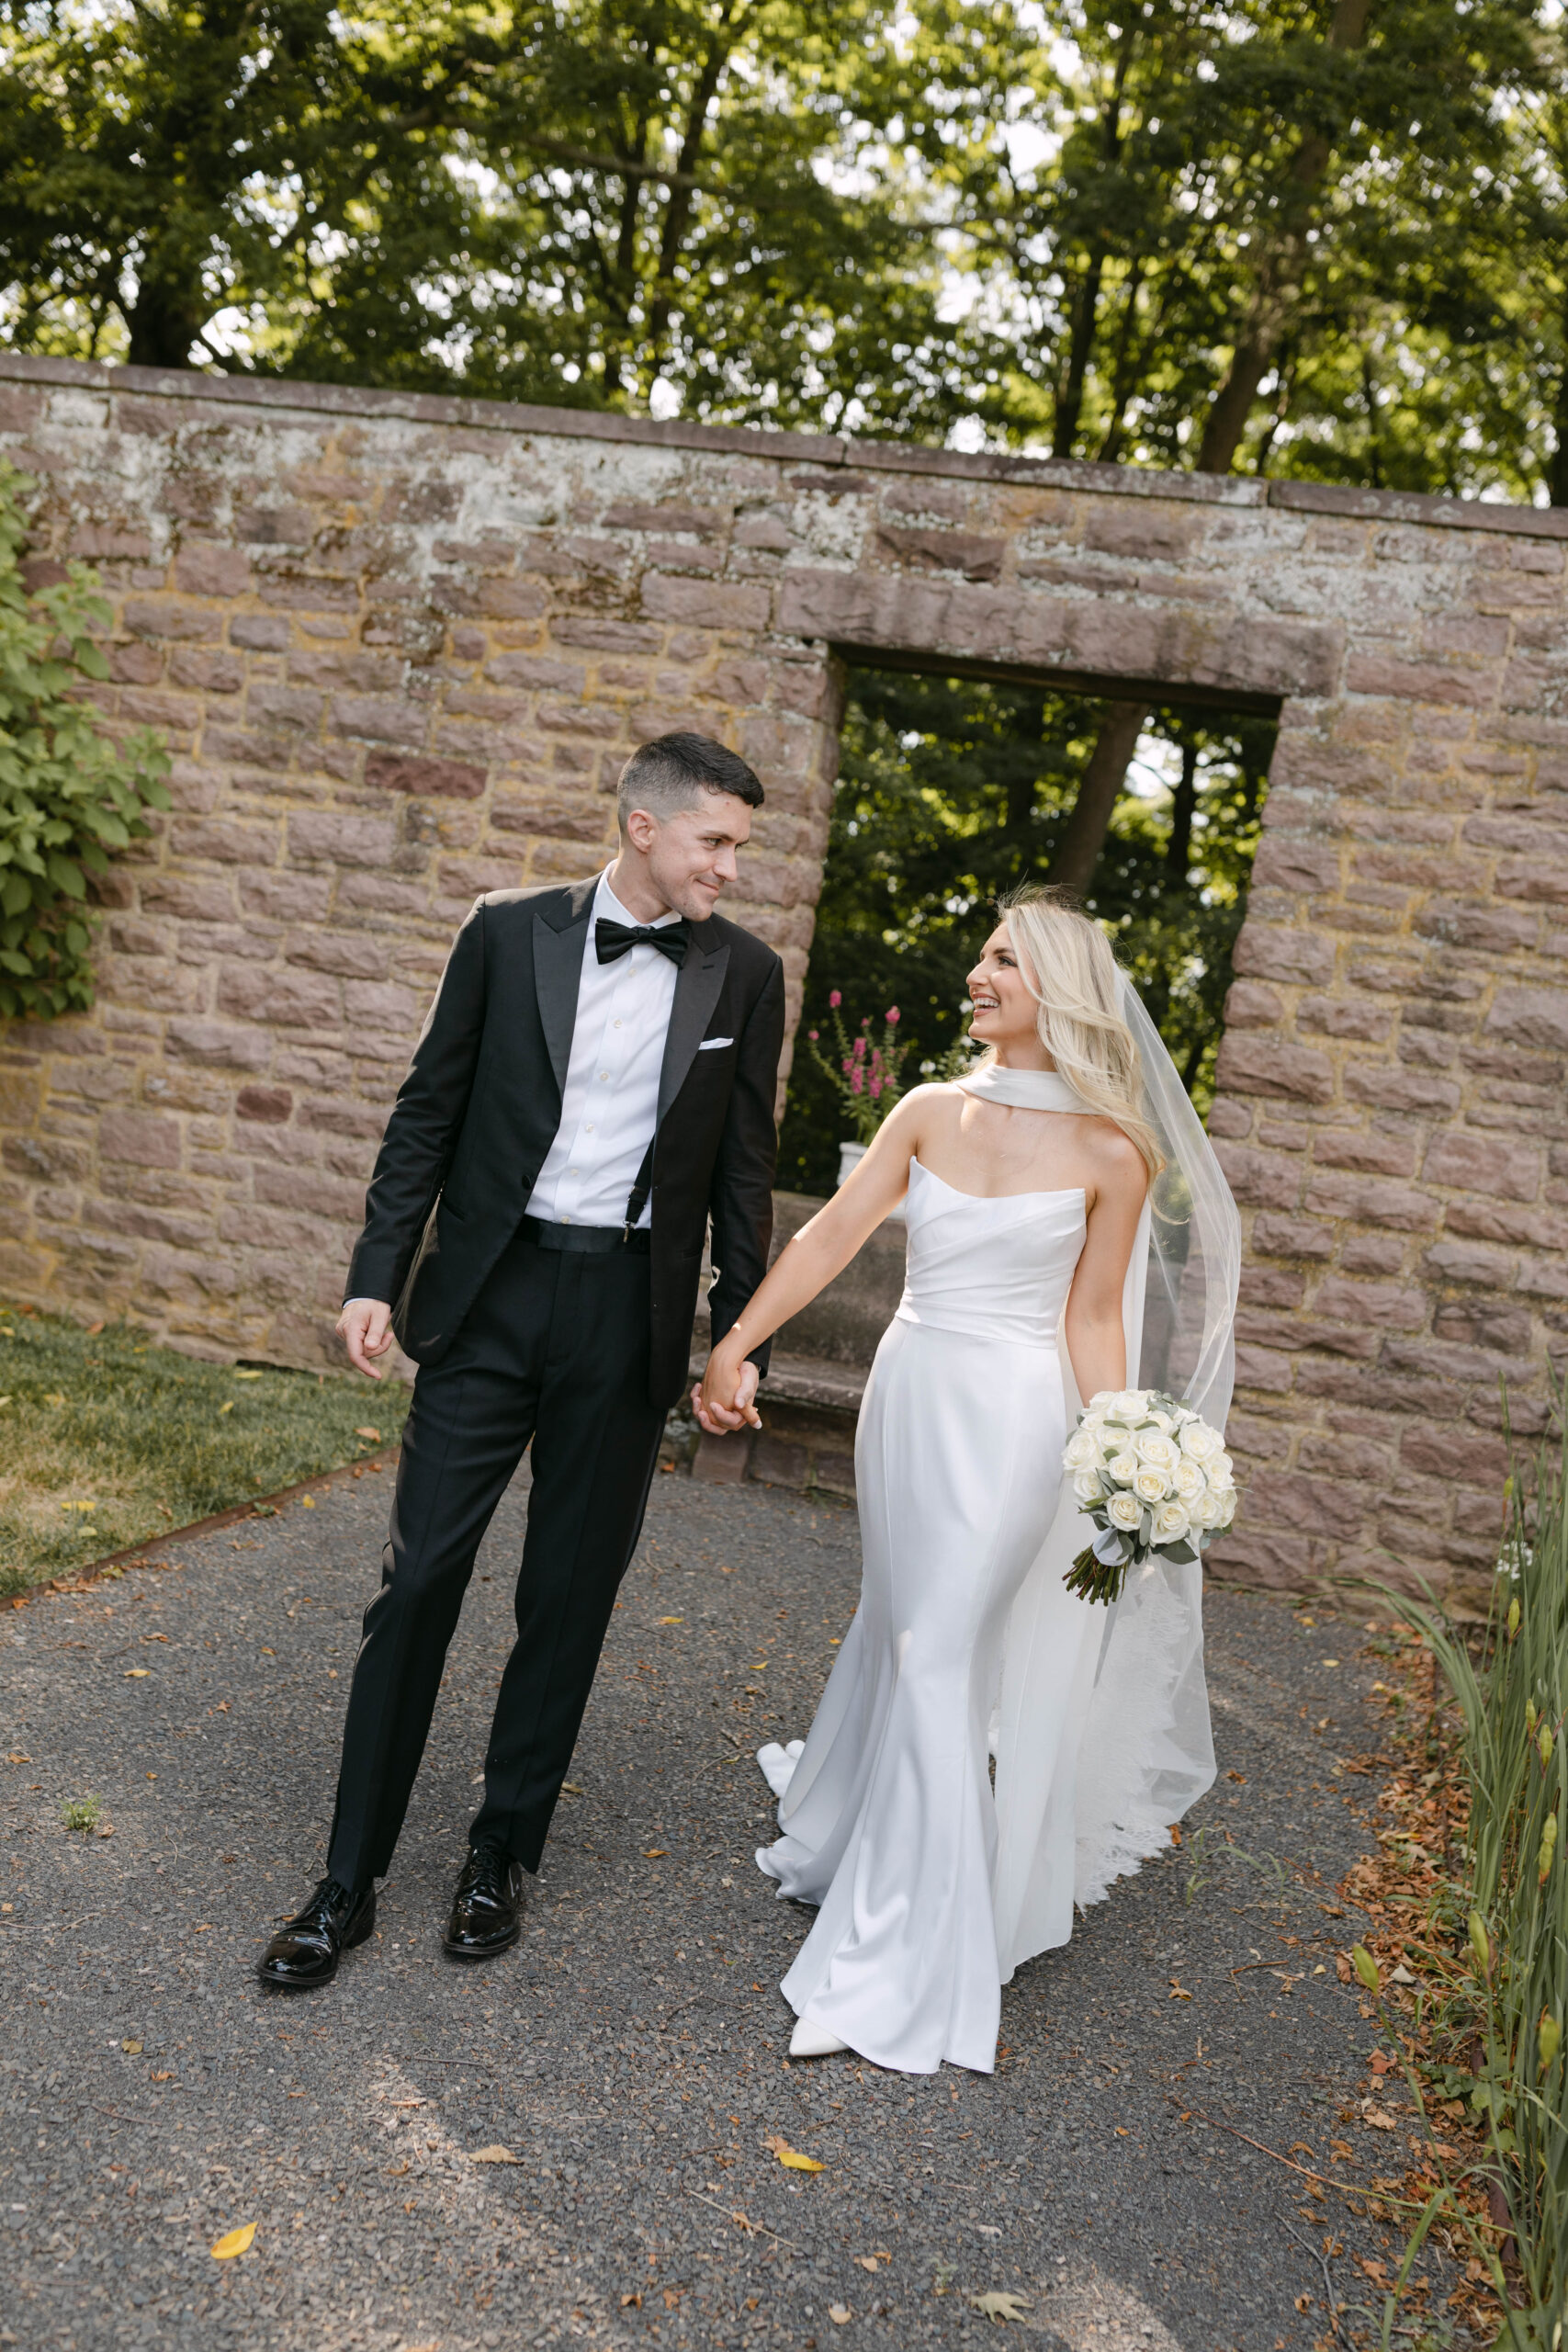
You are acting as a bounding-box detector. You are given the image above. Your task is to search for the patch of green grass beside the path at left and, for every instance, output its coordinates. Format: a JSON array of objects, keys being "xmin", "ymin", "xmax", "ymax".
[{"xmin": 0, "ymin": 1306, "xmax": 409, "ymax": 1595}]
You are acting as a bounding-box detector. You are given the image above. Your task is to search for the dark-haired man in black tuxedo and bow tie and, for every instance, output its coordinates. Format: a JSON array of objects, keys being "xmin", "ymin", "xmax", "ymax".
[{"xmin": 261, "ymin": 734, "xmax": 799, "ymax": 1987}]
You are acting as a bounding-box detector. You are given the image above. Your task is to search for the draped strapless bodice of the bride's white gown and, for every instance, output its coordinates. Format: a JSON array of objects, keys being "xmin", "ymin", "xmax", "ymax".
[{"xmin": 898, "ymin": 1159, "xmax": 1084, "ymax": 1348}]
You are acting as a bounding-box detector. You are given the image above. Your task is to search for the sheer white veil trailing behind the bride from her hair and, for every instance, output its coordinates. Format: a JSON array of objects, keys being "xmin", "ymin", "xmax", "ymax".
[{"xmin": 971, "ymin": 974, "xmax": 1241, "ymax": 1983}]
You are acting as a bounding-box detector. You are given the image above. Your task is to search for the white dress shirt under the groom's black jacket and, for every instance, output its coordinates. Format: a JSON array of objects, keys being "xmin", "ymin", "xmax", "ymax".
[{"xmin": 529, "ymin": 868, "xmax": 680, "ymax": 1226}]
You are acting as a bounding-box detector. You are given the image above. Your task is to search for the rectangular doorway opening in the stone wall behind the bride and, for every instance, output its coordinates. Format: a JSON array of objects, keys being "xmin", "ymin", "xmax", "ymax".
[{"xmin": 742, "ymin": 642, "xmax": 1279, "ymax": 1494}]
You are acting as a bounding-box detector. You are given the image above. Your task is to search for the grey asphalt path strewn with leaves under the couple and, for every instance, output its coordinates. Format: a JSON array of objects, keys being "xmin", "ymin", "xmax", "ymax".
[{"xmin": 0, "ymin": 1473, "xmax": 1446, "ymax": 2352}]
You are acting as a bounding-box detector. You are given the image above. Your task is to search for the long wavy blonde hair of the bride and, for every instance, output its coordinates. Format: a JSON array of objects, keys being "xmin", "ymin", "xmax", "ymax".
[{"xmin": 997, "ymin": 882, "xmax": 1166, "ymax": 1176}]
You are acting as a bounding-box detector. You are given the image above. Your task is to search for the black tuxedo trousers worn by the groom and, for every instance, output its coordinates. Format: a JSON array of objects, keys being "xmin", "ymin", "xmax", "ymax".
[{"xmin": 327, "ymin": 1227, "xmax": 665, "ymax": 1889}]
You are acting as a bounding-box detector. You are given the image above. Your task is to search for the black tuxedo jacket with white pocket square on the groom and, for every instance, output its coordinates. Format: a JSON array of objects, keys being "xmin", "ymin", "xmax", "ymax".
[{"xmin": 345, "ymin": 875, "xmax": 783, "ymax": 1407}]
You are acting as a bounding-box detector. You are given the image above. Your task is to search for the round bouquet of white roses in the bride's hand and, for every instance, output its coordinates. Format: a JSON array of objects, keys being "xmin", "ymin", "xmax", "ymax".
[{"xmin": 1063, "ymin": 1387, "xmax": 1236, "ymax": 1601}]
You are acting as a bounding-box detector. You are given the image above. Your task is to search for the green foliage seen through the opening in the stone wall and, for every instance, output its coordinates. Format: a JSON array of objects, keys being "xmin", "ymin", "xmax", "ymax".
[{"xmin": 778, "ymin": 671, "xmax": 1274, "ymax": 1193}]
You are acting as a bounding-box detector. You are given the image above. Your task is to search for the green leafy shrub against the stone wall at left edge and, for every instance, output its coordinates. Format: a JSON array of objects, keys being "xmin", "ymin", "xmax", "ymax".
[{"xmin": 0, "ymin": 461, "xmax": 169, "ymax": 1018}]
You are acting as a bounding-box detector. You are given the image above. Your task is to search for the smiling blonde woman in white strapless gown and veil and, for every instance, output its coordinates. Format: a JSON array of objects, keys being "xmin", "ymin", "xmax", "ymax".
[{"xmin": 696, "ymin": 889, "xmax": 1239, "ymax": 2075}]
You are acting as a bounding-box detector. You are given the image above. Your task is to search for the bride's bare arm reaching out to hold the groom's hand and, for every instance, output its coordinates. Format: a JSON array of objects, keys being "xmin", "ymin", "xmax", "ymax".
[{"xmin": 691, "ymin": 1087, "xmax": 931, "ymax": 1432}]
